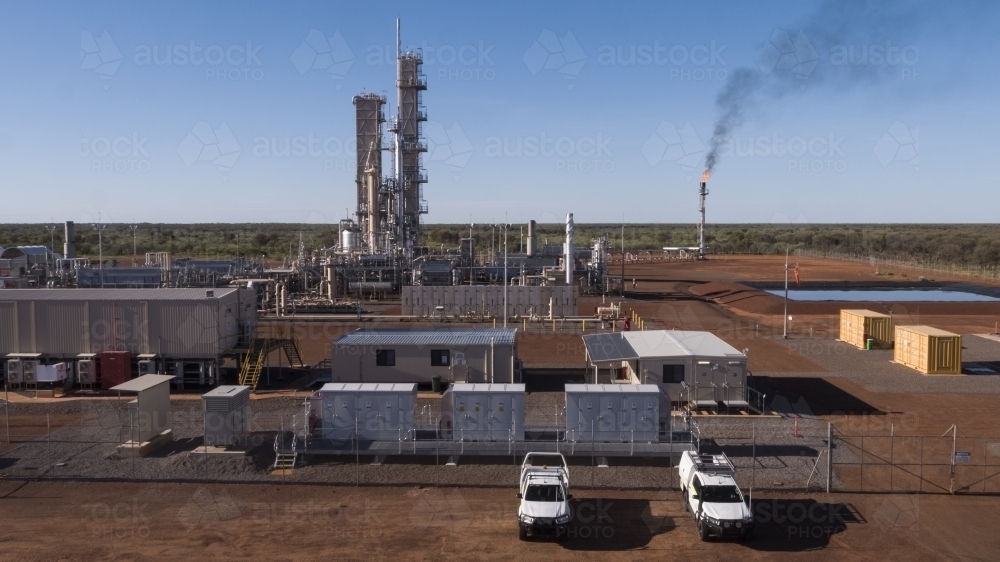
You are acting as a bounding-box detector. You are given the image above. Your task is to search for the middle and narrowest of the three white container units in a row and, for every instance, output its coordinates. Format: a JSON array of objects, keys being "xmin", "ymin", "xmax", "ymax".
[{"xmin": 441, "ymin": 383, "xmax": 524, "ymax": 441}]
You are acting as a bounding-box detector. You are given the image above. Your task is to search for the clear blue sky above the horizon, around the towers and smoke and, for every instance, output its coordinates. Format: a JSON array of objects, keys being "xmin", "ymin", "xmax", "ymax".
[{"xmin": 0, "ymin": 1, "xmax": 1000, "ymax": 223}]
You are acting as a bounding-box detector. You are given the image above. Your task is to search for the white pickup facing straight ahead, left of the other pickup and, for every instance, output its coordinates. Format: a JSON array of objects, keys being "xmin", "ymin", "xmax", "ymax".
[{"xmin": 517, "ymin": 453, "xmax": 573, "ymax": 540}]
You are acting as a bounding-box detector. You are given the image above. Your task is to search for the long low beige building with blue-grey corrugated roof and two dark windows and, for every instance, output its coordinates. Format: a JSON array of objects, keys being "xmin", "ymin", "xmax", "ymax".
[{"xmin": 331, "ymin": 328, "xmax": 520, "ymax": 383}]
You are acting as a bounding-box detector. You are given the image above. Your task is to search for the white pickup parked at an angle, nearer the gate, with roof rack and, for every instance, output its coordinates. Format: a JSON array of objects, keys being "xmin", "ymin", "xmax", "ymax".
[{"xmin": 678, "ymin": 451, "xmax": 754, "ymax": 541}]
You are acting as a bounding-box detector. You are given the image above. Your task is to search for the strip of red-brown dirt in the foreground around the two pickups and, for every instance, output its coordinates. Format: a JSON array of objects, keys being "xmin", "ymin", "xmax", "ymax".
[{"xmin": 0, "ymin": 481, "xmax": 1000, "ymax": 561}]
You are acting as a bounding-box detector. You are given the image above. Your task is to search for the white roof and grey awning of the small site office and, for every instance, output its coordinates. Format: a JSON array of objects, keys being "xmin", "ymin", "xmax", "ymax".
[{"xmin": 583, "ymin": 330, "xmax": 746, "ymax": 363}]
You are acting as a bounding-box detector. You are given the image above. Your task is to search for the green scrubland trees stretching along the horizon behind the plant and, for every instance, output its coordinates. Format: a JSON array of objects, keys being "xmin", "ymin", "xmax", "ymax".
[{"xmin": 0, "ymin": 223, "xmax": 1000, "ymax": 267}]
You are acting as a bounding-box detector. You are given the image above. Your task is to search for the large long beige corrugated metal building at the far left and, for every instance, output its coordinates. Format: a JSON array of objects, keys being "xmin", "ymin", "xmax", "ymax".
[{"xmin": 0, "ymin": 287, "xmax": 257, "ymax": 359}]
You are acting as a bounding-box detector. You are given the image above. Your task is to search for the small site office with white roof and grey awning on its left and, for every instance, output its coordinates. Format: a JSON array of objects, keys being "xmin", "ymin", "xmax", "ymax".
[{"xmin": 583, "ymin": 330, "xmax": 762, "ymax": 415}]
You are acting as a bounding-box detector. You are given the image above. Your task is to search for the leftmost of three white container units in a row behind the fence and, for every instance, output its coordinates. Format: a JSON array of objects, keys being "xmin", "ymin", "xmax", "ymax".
[{"xmin": 316, "ymin": 383, "xmax": 417, "ymax": 441}]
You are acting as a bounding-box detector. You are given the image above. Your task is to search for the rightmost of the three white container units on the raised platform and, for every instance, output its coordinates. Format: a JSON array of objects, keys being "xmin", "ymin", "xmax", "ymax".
[{"xmin": 566, "ymin": 384, "xmax": 663, "ymax": 443}]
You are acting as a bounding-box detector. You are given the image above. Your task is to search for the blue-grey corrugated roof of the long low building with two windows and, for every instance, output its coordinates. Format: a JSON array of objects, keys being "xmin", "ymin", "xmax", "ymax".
[{"xmin": 333, "ymin": 328, "xmax": 517, "ymax": 346}]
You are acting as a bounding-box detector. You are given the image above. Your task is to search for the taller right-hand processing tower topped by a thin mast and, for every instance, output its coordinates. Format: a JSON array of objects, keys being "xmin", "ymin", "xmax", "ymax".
[{"xmin": 390, "ymin": 20, "xmax": 427, "ymax": 255}]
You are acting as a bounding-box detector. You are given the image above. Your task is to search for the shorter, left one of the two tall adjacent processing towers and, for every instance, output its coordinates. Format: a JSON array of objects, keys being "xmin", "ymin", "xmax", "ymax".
[{"xmin": 354, "ymin": 94, "xmax": 389, "ymax": 254}]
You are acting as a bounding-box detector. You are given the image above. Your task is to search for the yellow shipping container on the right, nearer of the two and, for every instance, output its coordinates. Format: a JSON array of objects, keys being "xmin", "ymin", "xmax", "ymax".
[{"xmin": 892, "ymin": 326, "xmax": 962, "ymax": 375}]
